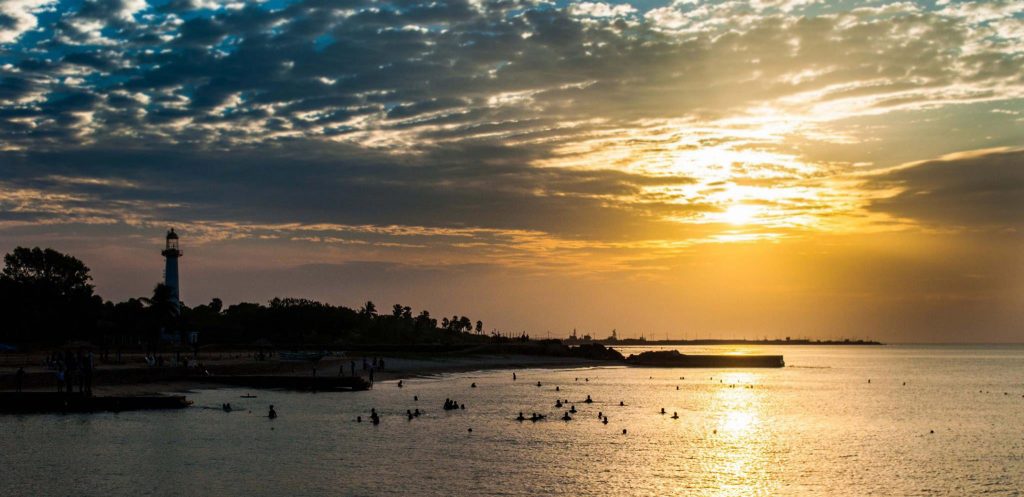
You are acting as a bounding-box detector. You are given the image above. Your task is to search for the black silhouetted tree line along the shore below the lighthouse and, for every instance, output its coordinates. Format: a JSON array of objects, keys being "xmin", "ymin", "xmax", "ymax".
[{"xmin": 0, "ymin": 247, "xmax": 504, "ymax": 347}]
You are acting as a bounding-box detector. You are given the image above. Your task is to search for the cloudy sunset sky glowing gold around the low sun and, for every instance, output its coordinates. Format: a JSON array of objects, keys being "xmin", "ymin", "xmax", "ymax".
[{"xmin": 0, "ymin": 0, "xmax": 1024, "ymax": 342}]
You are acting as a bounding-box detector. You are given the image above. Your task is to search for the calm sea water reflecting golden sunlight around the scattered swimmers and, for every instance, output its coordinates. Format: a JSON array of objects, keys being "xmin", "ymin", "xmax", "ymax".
[{"xmin": 0, "ymin": 345, "xmax": 1024, "ymax": 496}]
